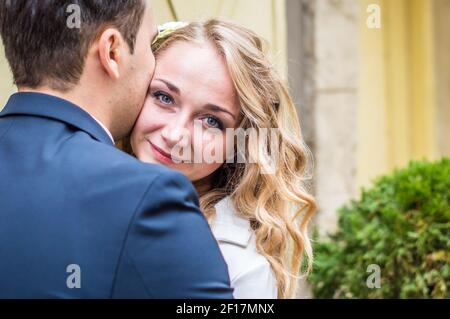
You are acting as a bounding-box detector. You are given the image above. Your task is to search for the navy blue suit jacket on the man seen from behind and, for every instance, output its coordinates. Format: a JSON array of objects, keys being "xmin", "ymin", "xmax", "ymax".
[{"xmin": 0, "ymin": 93, "xmax": 232, "ymax": 298}]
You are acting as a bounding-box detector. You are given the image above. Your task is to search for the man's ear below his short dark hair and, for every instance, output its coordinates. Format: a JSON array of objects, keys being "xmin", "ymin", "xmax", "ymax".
[{"xmin": 98, "ymin": 28, "xmax": 125, "ymax": 80}]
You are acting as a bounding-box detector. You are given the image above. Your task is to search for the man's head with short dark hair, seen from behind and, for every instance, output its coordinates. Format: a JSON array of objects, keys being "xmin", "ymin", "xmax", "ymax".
[{"xmin": 0, "ymin": 0, "xmax": 156, "ymax": 138}]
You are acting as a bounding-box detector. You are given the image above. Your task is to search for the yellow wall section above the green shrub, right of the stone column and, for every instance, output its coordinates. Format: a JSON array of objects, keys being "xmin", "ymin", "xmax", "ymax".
[{"xmin": 357, "ymin": 0, "xmax": 437, "ymax": 185}]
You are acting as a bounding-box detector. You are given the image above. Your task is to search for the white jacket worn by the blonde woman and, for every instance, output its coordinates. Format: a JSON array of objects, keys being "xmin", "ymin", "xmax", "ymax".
[{"xmin": 211, "ymin": 197, "xmax": 277, "ymax": 299}]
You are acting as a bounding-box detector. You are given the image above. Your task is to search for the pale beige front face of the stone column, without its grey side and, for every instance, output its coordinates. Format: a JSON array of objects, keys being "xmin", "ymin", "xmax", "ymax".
[{"xmin": 314, "ymin": 0, "xmax": 360, "ymax": 234}]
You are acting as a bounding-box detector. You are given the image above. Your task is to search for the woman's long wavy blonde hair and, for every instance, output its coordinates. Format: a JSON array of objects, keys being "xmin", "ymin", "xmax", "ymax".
[{"xmin": 153, "ymin": 19, "xmax": 316, "ymax": 298}]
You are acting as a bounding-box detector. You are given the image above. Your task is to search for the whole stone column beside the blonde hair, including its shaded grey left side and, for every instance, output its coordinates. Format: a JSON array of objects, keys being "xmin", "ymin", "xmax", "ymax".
[{"xmin": 286, "ymin": 0, "xmax": 360, "ymax": 298}]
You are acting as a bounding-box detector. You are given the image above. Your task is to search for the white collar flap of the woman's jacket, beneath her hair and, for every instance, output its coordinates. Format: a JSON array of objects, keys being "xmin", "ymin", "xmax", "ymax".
[{"xmin": 211, "ymin": 197, "xmax": 253, "ymax": 247}]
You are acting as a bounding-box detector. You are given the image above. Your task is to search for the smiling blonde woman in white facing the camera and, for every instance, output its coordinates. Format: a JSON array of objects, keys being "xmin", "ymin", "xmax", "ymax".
[{"xmin": 130, "ymin": 20, "xmax": 315, "ymax": 298}]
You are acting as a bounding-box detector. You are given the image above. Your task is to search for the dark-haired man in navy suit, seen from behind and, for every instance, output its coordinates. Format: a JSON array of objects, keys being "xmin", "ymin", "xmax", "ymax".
[{"xmin": 0, "ymin": 0, "xmax": 232, "ymax": 298}]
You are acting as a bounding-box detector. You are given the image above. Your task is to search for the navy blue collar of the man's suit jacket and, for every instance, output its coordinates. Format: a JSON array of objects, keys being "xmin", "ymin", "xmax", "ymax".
[{"xmin": 0, "ymin": 92, "xmax": 114, "ymax": 145}]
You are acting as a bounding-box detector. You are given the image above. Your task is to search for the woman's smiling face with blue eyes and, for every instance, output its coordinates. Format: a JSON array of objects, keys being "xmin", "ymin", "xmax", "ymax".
[{"xmin": 131, "ymin": 41, "xmax": 240, "ymax": 182}]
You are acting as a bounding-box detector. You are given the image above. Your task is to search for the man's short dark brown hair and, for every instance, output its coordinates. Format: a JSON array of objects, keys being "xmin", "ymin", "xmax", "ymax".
[{"xmin": 0, "ymin": 0, "xmax": 145, "ymax": 91}]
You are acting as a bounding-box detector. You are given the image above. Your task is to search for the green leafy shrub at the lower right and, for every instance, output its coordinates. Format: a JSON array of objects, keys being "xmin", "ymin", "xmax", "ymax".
[{"xmin": 310, "ymin": 158, "xmax": 450, "ymax": 298}]
